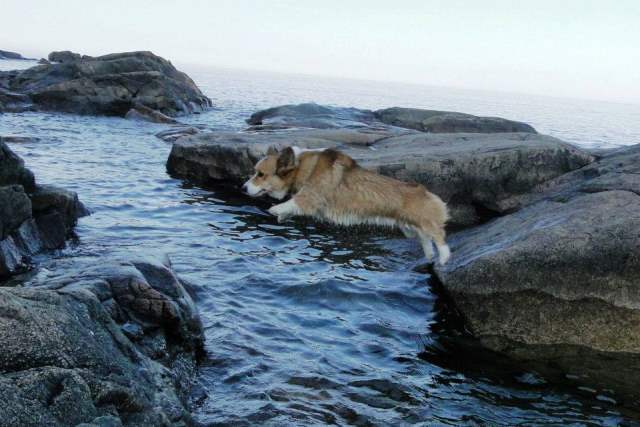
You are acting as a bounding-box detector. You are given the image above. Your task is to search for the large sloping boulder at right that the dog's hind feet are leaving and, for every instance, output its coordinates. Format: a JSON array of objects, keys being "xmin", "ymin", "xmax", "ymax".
[{"xmin": 436, "ymin": 145, "xmax": 640, "ymax": 398}]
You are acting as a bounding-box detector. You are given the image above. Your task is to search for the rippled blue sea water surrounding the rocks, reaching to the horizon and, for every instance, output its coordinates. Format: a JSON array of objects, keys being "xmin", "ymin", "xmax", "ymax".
[{"xmin": 0, "ymin": 61, "xmax": 640, "ymax": 426}]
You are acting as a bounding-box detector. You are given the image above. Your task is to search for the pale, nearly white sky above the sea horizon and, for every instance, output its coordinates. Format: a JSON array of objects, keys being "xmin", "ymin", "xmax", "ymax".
[{"xmin": 0, "ymin": 0, "xmax": 640, "ymax": 103}]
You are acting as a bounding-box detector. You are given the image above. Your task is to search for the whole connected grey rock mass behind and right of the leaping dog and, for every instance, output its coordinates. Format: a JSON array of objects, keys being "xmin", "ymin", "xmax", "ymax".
[{"xmin": 167, "ymin": 104, "xmax": 640, "ymax": 400}]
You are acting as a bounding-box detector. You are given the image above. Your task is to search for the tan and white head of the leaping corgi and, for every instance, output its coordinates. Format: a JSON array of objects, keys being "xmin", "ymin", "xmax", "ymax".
[{"xmin": 242, "ymin": 147, "xmax": 296, "ymax": 200}]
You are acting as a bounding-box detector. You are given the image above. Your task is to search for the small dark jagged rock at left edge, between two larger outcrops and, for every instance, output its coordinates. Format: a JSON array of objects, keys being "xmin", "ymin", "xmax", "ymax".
[{"xmin": 0, "ymin": 137, "xmax": 88, "ymax": 280}]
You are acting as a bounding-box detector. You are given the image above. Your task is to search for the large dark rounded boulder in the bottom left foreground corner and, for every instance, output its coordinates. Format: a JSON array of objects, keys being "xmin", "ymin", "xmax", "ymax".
[{"xmin": 0, "ymin": 259, "xmax": 203, "ymax": 426}]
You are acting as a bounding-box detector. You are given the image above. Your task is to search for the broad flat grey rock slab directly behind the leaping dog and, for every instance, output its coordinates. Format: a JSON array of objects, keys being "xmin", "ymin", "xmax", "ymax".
[{"xmin": 167, "ymin": 104, "xmax": 594, "ymax": 227}]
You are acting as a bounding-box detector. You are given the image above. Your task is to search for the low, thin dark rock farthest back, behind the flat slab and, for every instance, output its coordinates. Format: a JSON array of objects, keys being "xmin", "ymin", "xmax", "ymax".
[{"xmin": 375, "ymin": 107, "xmax": 536, "ymax": 133}]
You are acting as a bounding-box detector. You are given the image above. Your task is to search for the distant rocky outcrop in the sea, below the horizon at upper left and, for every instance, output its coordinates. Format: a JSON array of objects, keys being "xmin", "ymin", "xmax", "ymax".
[{"xmin": 0, "ymin": 52, "xmax": 211, "ymax": 117}]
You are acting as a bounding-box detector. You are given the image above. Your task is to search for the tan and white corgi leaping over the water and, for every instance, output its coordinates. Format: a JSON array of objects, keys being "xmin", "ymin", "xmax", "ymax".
[{"xmin": 242, "ymin": 147, "xmax": 451, "ymax": 264}]
